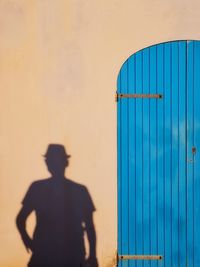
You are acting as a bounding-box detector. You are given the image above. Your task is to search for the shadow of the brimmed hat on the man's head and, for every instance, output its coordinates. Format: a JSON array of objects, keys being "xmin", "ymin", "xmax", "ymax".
[{"xmin": 43, "ymin": 144, "xmax": 71, "ymax": 159}]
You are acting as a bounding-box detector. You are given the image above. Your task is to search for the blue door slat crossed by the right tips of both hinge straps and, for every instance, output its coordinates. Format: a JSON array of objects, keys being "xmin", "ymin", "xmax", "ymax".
[{"xmin": 157, "ymin": 44, "xmax": 165, "ymax": 267}]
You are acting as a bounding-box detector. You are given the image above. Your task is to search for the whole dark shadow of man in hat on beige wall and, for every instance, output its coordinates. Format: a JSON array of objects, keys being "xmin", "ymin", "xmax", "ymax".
[{"xmin": 16, "ymin": 144, "xmax": 98, "ymax": 267}]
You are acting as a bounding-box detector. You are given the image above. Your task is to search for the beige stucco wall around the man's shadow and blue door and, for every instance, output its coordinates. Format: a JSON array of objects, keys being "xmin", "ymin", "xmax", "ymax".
[{"xmin": 0, "ymin": 0, "xmax": 200, "ymax": 267}]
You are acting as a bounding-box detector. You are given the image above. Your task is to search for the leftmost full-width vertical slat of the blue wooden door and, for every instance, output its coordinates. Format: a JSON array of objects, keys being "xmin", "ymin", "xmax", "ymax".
[{"xmin": 121, "ymin": 62, "xmax": 129, "ymax": 267}]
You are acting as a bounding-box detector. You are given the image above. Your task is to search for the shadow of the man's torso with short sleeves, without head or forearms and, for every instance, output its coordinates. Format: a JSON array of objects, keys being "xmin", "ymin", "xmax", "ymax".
[{"xmin": 23, "ymin": 178, "xmax": 95, "ymax": 267}]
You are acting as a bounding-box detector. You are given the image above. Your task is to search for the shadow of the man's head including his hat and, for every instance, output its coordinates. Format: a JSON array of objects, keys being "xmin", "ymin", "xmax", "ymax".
[{"xmin": 43, "ymin": 144, "xmax": 70, "ymax": 176}]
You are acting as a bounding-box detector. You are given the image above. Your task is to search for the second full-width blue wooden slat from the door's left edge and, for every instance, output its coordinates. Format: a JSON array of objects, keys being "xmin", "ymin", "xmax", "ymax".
[{"xmin": 128, "ymin": 56, "xmax": 136, "ymax": 267}]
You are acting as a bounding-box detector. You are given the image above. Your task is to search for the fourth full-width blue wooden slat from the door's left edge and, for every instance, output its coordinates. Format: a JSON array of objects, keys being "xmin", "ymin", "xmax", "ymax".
[{"xmin": 143, "ymin": 49, "xmax": 151, "ymax": 267}]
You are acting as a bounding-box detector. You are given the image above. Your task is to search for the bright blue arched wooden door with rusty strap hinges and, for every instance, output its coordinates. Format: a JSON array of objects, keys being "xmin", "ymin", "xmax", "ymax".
[{"xmin": 117, "ymin": 41, "xmax": 200, "ymax": 267}]
